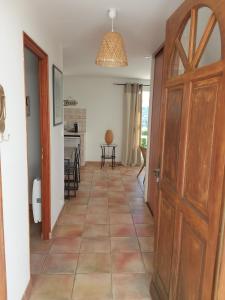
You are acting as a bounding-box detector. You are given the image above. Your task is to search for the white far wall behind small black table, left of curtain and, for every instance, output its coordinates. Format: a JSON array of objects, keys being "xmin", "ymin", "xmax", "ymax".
[{"xmin": 64, "ymin": 76, "xmax": 123, "ymax": 161}]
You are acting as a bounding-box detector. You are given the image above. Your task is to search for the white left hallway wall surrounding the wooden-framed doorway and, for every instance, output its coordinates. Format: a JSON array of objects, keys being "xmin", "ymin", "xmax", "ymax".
[{"xmin": 0, "ymin": 0, "xmax": 63, "ymax": 300}]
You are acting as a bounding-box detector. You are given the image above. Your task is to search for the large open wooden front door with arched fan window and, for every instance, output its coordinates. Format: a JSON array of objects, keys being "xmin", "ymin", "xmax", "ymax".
[{"xmin": 151, "ymin": 0, "xmax": 225, "ymax": 300}]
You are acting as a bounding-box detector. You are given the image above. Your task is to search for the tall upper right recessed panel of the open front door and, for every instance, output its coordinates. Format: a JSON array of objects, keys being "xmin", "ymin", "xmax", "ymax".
[{"xmin": 183, "ymin": 78, "xmax": 220, "ymax": 219}]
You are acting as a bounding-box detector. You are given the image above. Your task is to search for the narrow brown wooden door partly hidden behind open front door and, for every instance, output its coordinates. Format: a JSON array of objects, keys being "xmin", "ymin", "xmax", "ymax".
[{"xmin": 148, "ymin": 46, "xmax": 164, "ymax": 215}]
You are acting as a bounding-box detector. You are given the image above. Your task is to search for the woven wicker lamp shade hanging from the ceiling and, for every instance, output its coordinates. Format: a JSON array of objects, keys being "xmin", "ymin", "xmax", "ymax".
[{"xmin": 96, "ymin": 32, "xmax": 128, "ymax": 67}]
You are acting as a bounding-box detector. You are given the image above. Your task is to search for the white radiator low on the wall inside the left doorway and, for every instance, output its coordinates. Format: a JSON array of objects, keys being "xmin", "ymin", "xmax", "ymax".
[{"xmin": 32, "ymin": 178, "xmax": 41, "ymax": 223}]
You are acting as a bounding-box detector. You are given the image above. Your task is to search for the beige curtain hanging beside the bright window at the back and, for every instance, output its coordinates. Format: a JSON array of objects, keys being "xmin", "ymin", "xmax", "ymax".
[{"xmin": 122, "ymin": 84, "xmax": 142, "ymax": 166}]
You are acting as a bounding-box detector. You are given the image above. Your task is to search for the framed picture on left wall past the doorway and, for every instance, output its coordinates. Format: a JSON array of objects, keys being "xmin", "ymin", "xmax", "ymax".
[{"xmin": 52, "ymin": 65, "xmax": 63, "ymax": 126}]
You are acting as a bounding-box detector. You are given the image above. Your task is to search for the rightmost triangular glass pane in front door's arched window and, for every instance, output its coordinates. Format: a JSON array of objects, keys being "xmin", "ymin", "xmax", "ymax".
[{"xmin": 198, "ymin": 22, "xmax": 221, "ymax": 67}]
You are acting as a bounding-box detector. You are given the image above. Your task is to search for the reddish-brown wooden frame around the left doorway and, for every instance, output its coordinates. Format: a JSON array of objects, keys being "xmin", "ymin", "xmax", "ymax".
[{"xmin": 23, "ymin": 32, "xmax": 51, "ymax": 240}]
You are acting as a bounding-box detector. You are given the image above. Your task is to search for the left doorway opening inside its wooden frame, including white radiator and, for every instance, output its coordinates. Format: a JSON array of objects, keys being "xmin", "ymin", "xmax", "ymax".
[{"xmin": 24, "ymin": 48, "xmax": 42, "ymax": 244}]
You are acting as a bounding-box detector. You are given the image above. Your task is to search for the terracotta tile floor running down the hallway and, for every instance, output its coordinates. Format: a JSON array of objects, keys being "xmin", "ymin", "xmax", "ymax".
[{"xmin": 31, "ymin": 165, "xmax": 153, "ymax": 300}]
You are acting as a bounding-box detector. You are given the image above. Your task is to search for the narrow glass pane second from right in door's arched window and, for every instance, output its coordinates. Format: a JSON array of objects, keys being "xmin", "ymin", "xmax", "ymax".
[{"xmin": 196, "ymin": 6, "xmax": 213, "ymax": 49}]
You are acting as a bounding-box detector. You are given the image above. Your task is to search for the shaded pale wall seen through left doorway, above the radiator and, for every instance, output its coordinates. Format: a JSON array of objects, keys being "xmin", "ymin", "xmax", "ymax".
[{"xmin": 24, "ymin": 49, "xmax": 41, "ymax": 203}]
